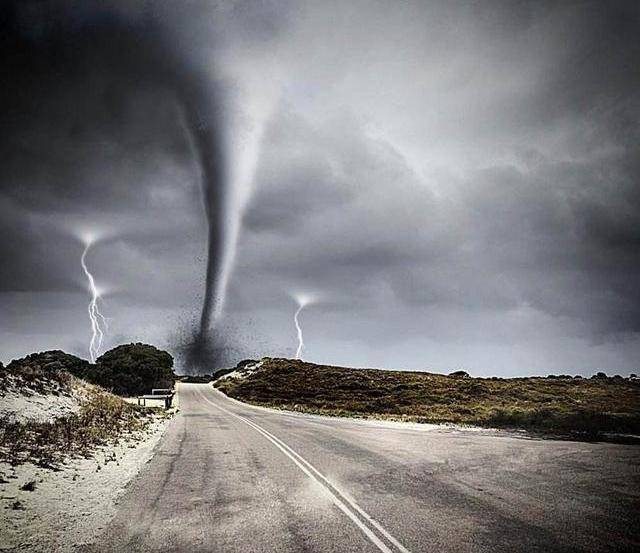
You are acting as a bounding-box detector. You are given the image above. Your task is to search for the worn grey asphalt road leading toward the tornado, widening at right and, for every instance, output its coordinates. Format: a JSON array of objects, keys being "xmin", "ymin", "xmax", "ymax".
[{"xmin": 82, "ymin": 384, "xmax": 640, "ymax": 553}]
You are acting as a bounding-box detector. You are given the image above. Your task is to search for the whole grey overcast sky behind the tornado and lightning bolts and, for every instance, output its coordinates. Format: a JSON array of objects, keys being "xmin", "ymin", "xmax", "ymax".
[{"xmin": 0, "ymin": 0, "xmax": 640, "ymax": 375}]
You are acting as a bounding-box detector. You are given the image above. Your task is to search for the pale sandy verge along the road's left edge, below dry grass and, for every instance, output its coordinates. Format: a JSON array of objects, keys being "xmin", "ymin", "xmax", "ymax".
[{"xmin": 0, "ymin": 419, "xmax": 170, "ymax": 553}]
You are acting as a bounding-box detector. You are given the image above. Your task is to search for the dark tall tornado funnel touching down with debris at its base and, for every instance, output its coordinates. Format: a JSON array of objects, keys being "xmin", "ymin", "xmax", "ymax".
[{"xmin": 96, "ymin": 23, "xmax": 230, "ymax": 373}]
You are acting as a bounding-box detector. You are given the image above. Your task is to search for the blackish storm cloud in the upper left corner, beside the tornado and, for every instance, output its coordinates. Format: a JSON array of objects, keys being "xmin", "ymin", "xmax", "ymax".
[{"xmin": 0, "ymin": 2, "xmax": 208, "ymax": 280}]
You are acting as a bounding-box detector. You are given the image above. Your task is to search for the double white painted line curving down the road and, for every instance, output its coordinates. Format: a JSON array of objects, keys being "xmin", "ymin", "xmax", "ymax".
[{"xmin": 198, "ymin": 389, "xmax": 411, "ymax": 553}]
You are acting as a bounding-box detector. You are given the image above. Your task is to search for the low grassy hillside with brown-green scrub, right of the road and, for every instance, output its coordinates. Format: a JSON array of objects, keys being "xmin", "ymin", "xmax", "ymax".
[{"xmin": 214, "ymin": 358, "xmax": 640, "ymax": 436}]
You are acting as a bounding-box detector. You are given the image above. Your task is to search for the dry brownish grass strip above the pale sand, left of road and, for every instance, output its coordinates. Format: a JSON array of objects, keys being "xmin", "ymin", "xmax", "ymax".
[{"xmin": 0, "ymin": 388, "xmax": 158, "ymax": 467}]
